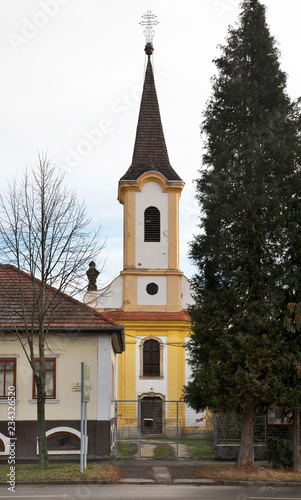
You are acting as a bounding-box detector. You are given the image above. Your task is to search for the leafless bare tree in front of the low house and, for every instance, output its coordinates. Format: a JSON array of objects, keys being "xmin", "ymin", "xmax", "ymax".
[{"xmin": 0, "ymin": 155, "xmax": 103, "ymax": 469}]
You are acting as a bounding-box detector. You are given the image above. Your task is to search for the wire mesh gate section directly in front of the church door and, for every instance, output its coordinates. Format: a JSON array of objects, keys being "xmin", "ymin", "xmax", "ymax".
[{"xmin": 112, "ymin": 397, "xmax": 213, "ymax": 459}]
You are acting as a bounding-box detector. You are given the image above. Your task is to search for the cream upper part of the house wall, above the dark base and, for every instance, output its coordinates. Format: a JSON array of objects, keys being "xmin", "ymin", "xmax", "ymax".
[{"xmin": 0, "ymin": 333, "xmax": 98, "ymax": 421}]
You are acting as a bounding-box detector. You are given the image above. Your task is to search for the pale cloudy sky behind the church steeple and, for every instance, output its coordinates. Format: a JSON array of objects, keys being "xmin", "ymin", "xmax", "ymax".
[{"xmin": 0, "ymin": 0, "xmax": 301, "ymax": 288}]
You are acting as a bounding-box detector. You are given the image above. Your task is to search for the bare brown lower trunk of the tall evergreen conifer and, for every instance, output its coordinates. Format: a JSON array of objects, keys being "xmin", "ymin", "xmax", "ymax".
[{"xmin": 237, "ymin": 406, "xmax": 255, "ymax": 467}]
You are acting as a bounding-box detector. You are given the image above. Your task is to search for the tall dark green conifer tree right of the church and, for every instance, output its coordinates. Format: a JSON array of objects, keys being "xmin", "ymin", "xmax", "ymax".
[{"xmin": 185, "ymin": 0, "xmax": 300, "ymax": 466}]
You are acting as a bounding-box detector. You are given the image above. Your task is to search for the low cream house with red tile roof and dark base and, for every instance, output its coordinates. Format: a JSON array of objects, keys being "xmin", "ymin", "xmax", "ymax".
[{"xmin": 0, "ymin": 265, "xmax": 125, "ymax": 462}]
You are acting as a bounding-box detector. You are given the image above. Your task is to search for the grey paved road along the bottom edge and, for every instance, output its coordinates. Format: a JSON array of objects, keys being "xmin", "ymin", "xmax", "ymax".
[{"xmin": 0, "ymin": 484, "xmax": 301, "ymax": 500}]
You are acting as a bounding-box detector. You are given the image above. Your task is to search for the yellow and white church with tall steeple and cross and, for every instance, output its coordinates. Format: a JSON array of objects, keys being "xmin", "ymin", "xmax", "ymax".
[{"xmin": 84, "ymin": 12, "xmax": 206, "ymax": 437}]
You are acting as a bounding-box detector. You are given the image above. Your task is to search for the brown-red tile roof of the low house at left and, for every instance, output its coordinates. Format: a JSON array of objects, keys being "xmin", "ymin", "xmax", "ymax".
[{"xmin": 0, "ymin": 264, "xmax": 121, "ymax": 332}]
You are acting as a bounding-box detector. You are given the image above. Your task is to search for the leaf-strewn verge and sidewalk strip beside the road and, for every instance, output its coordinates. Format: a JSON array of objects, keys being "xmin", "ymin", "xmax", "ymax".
[{"xmin": 0, "ymin": 459, "xmax": 301, "ymax": 489}]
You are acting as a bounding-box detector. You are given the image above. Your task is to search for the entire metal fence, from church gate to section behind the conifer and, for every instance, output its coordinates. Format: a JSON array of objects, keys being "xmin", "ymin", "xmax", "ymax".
[{"xmin": 112, "ymin": 397, "xmax": 292, "ymax": 459}]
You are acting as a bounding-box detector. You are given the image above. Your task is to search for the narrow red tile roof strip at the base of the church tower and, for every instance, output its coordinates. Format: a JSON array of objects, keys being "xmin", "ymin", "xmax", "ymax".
[{"xmin": 103, "ymin": 310, "xmax": 190, "ymax": 321}]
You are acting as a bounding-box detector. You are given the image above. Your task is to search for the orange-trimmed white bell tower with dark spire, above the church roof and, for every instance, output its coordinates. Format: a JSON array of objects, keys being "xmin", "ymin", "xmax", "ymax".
[{"xmin": 118, "ymin": 27, "xmax": 184, "ymax": 312}]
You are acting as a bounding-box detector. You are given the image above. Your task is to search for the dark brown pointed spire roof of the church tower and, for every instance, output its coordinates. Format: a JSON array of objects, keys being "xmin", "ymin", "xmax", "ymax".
[{"xmin": 120, "ymin": 50, "xmax": 181, "ymax": 181}]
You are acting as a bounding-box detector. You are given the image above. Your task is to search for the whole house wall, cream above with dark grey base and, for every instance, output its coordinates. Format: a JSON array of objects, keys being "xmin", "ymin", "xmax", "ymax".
[{"xmin": 0, "ymin": 333, "xmax": 116, "ymax": 461}]
